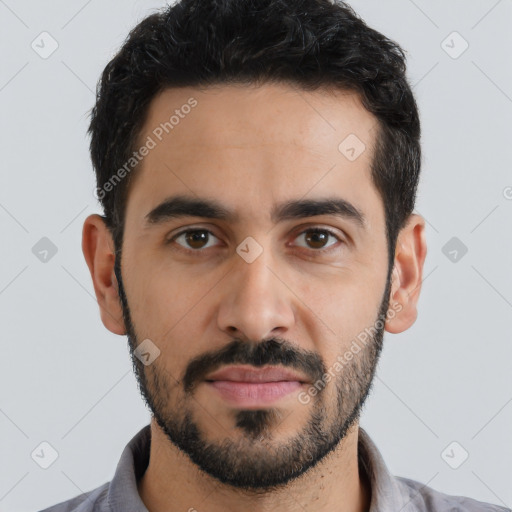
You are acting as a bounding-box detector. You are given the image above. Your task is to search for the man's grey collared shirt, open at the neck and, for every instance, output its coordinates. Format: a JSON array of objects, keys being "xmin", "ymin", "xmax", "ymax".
[{"xmin": 40, "ymin": 425, "xmax": 512, "ymax": 512}]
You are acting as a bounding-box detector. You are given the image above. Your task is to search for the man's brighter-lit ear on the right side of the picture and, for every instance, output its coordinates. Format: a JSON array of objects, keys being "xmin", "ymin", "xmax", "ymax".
[{"xmin": 385, "ymin": 214, "xmax": 427, "ymax": 334}]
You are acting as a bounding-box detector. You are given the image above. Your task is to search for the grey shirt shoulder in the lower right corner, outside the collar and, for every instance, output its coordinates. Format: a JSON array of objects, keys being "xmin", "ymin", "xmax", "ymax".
[{"xmin": 395, "ymin": 476, "xmax": 512, "ymax": 512}]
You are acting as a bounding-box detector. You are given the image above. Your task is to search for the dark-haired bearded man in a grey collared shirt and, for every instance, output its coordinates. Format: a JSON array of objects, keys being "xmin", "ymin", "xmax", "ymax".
[{"xmin": 39, "ymin": 0, "xmax": 506, "ymax": 512}]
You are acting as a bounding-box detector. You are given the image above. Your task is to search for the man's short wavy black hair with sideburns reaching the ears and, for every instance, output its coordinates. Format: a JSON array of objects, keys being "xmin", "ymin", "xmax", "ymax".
[{"xmin": 88, "ymin": 0, "xmax": 421, "ymax": 269}]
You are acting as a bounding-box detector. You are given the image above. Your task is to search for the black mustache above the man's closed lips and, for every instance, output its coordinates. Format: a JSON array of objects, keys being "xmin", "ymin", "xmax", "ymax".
[{"xmin": 182, "ymin": 338, "xmax": 327, "ymax": 393}]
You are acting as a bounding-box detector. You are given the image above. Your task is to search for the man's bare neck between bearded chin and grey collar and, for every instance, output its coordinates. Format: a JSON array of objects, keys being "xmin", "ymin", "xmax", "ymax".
[{"xmin": 138, "ymin": 419, "xmax": 371, "ymax": 512}]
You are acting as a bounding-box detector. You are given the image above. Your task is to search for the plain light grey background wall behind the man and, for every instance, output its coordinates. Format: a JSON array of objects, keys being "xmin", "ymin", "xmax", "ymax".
[{"xmin": 0, "ymin": 0, "xmax": 512, "ymax": 512}]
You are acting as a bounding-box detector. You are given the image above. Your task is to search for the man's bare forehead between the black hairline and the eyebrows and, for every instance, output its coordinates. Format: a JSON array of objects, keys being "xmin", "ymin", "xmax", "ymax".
[{"xmin": 124, "ymin": 84, "xmax": 379, "ymax": 226}]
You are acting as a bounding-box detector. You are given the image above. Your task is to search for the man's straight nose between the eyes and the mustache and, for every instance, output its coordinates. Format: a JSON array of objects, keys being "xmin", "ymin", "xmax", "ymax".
[{"xmin": 218, "ymin": 249, "xmax": 295, "ymax": 341}]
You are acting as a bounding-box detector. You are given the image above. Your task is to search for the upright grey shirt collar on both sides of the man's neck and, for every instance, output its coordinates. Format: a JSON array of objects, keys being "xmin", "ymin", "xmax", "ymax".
[{"xmin": 107, "ymin": 425, "xmax": 411, "ymax": 512}]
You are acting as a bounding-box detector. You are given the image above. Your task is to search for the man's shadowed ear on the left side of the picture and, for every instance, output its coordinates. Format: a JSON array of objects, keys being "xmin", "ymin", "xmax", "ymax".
[{"xmin": 82, "ymin": 214, "xmax": 126, "ymax": 335}]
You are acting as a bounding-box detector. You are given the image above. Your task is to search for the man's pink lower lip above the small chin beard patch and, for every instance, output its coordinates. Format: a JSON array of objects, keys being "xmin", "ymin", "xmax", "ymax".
[{"xmin": 207, "ymin": 380, "xmax": 302, "ymax": 406}]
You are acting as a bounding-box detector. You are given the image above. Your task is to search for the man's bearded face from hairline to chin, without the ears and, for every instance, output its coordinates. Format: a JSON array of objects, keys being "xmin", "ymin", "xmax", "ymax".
[{"xmin": 118, "ymin": 85, "xmax": 389, "ymax": 490}]
